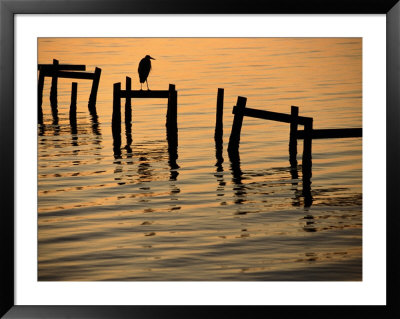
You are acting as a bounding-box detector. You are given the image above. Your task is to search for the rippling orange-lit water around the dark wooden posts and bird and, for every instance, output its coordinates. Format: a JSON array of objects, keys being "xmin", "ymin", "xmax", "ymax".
[{"xmin": 38, "ymin": 38, "xmax": 362, "ymax": 281}]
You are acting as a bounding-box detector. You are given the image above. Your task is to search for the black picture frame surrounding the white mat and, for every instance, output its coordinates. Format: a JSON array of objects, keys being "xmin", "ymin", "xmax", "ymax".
[{"xmin": 0, "ymin": 0, "xmax": 400, "ymax": 318}]
